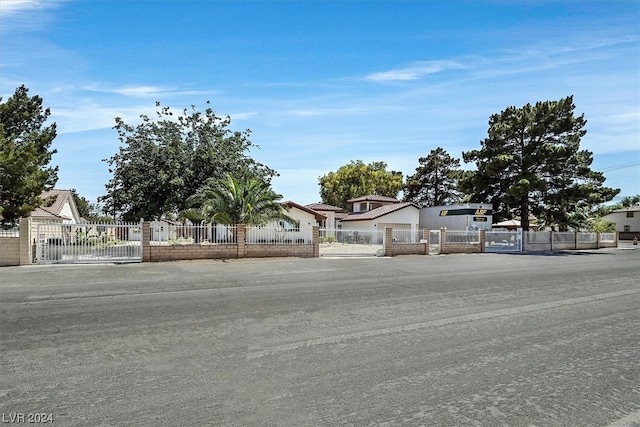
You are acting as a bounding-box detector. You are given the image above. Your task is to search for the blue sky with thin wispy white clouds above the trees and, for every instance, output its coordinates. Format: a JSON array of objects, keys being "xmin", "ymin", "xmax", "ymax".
[{"xmin": 0, "ymin": 0, "xmax": 640, "ymax": 204}]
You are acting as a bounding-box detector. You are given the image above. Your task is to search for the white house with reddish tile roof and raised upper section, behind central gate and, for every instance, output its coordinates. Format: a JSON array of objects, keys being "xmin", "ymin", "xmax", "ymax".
[{"xmin": 338, "ymin": 195, "xmax": 420, "ymax": 242}]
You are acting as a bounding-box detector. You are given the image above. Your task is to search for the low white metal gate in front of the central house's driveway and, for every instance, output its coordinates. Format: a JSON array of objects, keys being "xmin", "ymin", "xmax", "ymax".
[{"xmin": 320, "ymin": 228, "xmax": 384, "ymax": 257}]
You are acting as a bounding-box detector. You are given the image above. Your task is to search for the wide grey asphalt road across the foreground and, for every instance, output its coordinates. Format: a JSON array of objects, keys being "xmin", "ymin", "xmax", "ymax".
[{"xmin": 0, "ymin": 249, "xmax": 640, "ymax": 427}]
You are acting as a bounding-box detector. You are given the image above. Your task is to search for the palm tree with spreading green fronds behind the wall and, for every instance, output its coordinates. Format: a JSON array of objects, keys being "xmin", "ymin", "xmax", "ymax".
[{"xmin": 186, "ymin": 174, "xmax": 295, "ymax": 225}]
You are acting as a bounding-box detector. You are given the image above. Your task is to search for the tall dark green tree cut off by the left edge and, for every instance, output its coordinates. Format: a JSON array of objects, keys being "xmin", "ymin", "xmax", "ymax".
[{"xmin": 0, "ymin": 85, "xmax": 58, "ymax": 227}]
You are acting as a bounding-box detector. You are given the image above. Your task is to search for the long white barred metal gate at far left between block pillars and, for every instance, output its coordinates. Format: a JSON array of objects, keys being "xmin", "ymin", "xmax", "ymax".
[{"xmin": 36, "ymin": 223, "xmax": 142, "ymax": 264}]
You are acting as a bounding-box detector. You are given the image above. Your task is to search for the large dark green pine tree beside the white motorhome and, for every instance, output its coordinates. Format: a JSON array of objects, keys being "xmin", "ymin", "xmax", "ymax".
[{"xmin": 462, "ymin": 96, "xmax": 619, "ymax": 229}]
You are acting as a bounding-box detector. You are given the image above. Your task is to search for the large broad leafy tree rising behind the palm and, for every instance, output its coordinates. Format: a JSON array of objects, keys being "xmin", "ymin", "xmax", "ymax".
[{"xmin": 100, "ymin": 103, "xmax": 276, "ymax": 220}]
